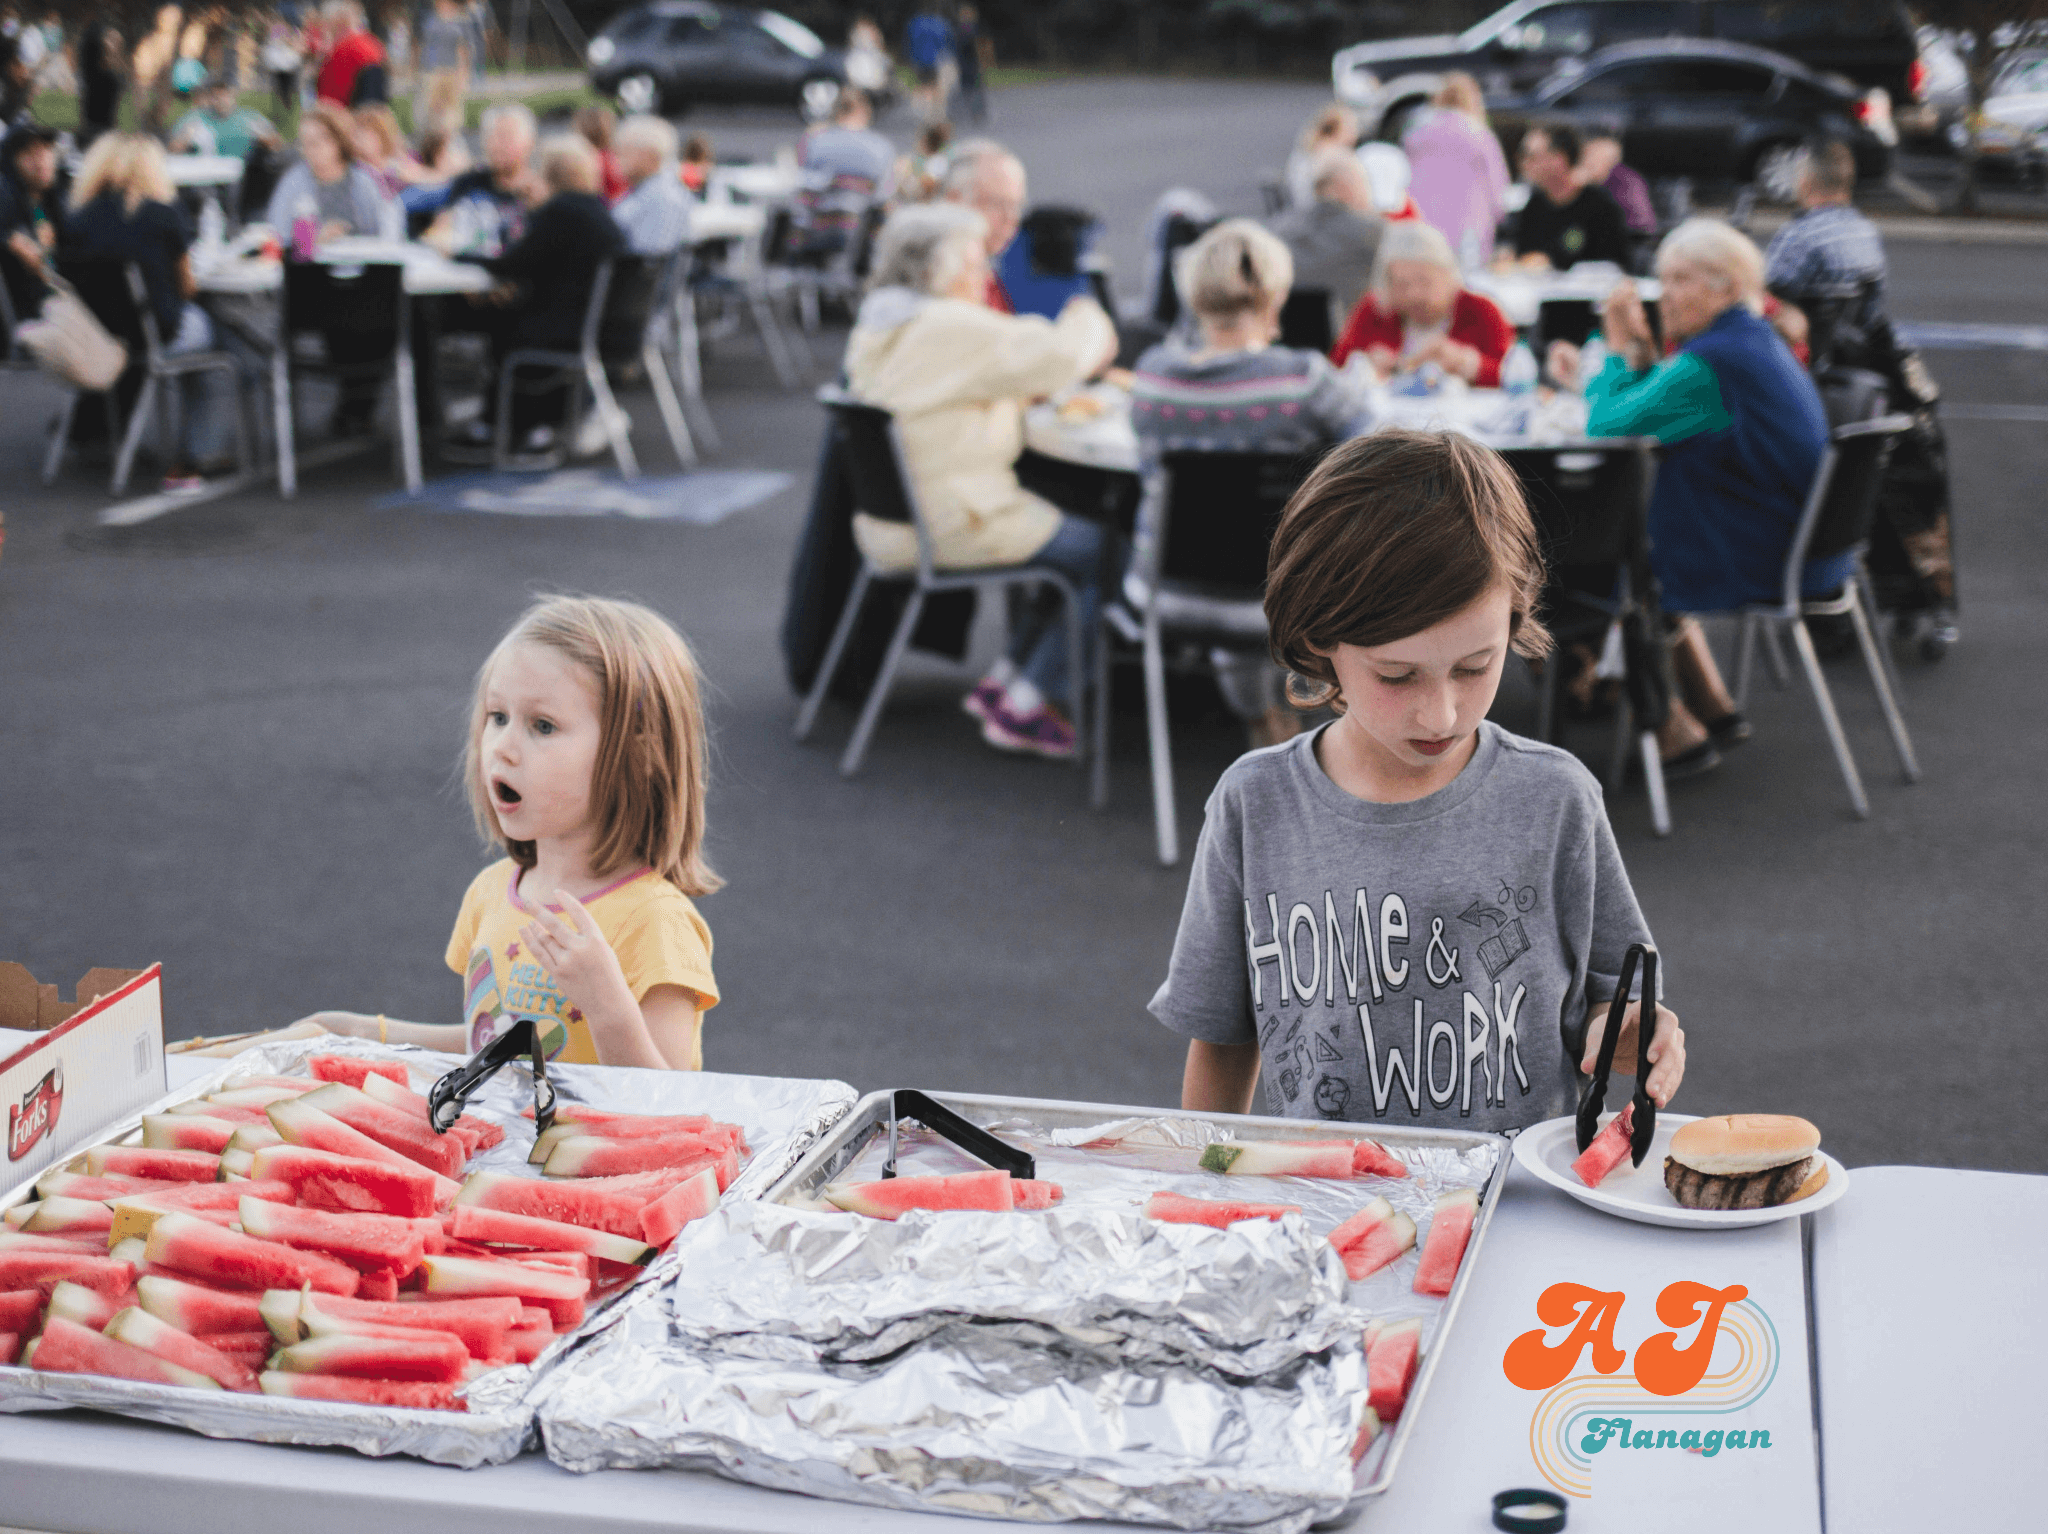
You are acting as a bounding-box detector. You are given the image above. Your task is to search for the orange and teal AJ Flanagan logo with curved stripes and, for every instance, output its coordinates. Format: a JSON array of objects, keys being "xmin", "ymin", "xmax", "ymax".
[{"xmin": 1501, "ymin": 1282, "xmax": 1778, "ymax": 1497}]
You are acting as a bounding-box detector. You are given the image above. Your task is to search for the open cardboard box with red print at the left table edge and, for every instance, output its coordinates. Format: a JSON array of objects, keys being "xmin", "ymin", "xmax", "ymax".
[{"xmin": 0, "ymin": 961, "xmax": 164, "ymax": 1190}]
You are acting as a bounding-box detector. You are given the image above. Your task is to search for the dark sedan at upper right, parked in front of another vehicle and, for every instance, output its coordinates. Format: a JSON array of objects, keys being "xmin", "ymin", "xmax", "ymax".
[{"xmin": 1487, "ymin": 39, "xmax": 1892, "ymax": 197}]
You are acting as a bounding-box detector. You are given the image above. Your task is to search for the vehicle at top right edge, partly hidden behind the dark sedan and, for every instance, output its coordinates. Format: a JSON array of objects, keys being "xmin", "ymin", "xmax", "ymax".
[{"xmin": 1331, "ymin": 0, "xmax": 1927, "ymax": 141}]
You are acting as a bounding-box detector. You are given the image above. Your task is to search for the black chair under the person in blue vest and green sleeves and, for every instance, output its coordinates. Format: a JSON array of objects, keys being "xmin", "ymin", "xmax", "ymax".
[{"xmin": 1735, "ymin": 416, "xmax": 1921, "ymax": 819}]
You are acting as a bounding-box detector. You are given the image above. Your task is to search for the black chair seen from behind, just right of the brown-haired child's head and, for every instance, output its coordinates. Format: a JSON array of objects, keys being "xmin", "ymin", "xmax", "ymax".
[{"xmin": 1501, "ymin": 438, "xmax": 1671, "ymax": 836}]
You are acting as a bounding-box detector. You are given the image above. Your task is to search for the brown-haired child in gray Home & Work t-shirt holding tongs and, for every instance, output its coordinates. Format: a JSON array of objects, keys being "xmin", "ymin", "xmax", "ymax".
[{"xmin": 1151, "ymin": 432, "xmax": 1686, "ymax": 1128}]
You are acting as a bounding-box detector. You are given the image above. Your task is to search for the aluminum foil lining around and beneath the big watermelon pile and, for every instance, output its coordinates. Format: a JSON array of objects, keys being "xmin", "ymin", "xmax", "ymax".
[{"xmin": 0, "ymin": 1036, "xmax": 854, "ymax": 1468}]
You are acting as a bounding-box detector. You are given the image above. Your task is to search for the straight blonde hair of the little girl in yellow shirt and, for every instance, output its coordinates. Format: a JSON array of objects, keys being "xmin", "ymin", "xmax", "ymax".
[{"xmin": 463, "ymin": 596, "xmax": 725, "ymax": 895}]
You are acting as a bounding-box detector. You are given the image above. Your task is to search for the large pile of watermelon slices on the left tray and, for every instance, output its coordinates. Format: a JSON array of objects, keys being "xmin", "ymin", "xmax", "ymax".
[{"xmin": 0, "ymin": 1055, "xmax": 745, "ymax": 1411}]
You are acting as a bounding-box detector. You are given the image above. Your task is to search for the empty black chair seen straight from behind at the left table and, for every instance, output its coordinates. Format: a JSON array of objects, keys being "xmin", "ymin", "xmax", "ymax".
[{"xmin": 270, "ymin": 260, "xmax": 422, "ymax": 496}]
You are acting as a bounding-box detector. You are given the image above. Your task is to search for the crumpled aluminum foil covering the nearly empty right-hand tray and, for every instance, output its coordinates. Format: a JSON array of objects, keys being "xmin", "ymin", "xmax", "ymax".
[{"xmin": 537, "ymin": 1098, "xmax": 1503, "ymax": 1534}]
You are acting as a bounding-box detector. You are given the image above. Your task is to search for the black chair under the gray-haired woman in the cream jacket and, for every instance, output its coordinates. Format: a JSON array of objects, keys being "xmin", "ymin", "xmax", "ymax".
[{"xmin": 797, "ymin": 389, "xmax": 1100, "ymax": 776}]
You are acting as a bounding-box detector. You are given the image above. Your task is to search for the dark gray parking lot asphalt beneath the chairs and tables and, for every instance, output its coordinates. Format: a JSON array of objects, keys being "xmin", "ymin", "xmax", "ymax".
[{"xmin": 0, "ymin": 80, "xmax": 2048, "ymax": 1171}]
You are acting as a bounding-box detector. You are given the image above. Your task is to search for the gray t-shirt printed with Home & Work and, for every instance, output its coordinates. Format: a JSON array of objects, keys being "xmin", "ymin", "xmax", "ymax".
[{"xmin": 1151, "ymin": 723, "xmax": 1649, "ymax": 1128}]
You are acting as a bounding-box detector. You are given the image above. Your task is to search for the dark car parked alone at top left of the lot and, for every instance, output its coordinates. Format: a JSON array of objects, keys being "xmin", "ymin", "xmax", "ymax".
[{"xmin": 588, "ymin": 0, "xmax": 846, "ymax": 117}]
